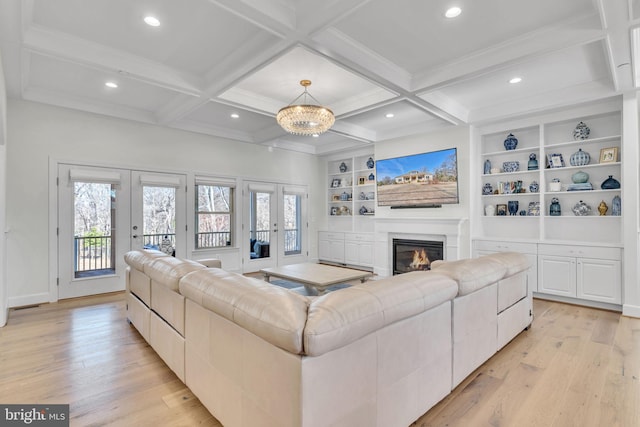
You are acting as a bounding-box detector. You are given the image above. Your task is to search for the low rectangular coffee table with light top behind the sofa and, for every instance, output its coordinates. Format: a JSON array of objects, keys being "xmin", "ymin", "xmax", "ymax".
[{"xmin": 260, "ymin": 262, "xmax": 373, "ymax": 295}]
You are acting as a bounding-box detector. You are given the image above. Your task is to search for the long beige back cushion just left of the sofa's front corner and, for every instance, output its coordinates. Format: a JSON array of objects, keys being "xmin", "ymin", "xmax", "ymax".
[{"xmin": 180, "ymin": 268, "xmax": 309, "ymax": 354}]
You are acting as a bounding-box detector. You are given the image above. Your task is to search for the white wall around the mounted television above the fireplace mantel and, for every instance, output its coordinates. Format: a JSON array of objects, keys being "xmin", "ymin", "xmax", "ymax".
[{"xmin": 375, "ymin": 126, "xmax": 471, "ymax": 258}]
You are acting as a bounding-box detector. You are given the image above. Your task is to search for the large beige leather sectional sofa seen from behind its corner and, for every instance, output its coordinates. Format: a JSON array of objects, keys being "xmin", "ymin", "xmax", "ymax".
[{"xmin": 125, "ymin": 251, "xmax": 532, "ymax": 427}]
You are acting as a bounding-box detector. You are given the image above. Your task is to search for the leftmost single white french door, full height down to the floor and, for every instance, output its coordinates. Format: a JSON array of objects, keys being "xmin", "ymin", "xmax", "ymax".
[{"xmin": 58, "ymin": 164, "xmax": 131, "ymax": 299}]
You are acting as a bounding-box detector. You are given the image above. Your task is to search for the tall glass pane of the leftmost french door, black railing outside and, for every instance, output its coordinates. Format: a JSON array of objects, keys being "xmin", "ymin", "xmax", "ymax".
[{"xmin": 73, "ymin": 182, "xmax": 116, "ymax": 278}]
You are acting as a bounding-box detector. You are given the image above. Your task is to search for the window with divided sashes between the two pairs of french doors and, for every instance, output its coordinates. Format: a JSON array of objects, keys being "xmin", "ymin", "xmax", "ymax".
[{"xmin": 196, "ymin": 181, "xmax": 234, "ymax": 249}]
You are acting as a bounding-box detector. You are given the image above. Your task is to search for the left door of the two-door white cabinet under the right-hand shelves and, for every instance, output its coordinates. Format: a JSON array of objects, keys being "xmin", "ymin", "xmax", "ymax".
[{"xmin": 538, "ymin": 255, "xmax": 576, "ymax": 298}]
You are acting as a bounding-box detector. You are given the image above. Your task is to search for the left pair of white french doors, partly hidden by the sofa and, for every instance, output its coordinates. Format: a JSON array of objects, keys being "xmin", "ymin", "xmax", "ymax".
[{"xmin": 58, "ymin": 164, "xmax": 187, "ymax": 299}]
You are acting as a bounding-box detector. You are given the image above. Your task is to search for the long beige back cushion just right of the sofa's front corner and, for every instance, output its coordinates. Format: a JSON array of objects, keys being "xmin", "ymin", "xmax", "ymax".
[{"xmin": 304, "ymin": 271, "xmax": 458, "ymax": 356}]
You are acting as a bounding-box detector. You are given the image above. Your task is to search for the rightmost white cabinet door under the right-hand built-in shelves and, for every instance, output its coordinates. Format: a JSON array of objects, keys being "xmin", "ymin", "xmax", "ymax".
[{"xmin": 577, "ymin": 258, "xmax": 622, "ymax": 304}]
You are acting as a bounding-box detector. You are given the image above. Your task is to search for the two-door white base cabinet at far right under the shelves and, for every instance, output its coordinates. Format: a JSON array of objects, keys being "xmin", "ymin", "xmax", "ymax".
[{"xmin": 538, "ymin": 244, "xmax": 622, "ymax": 304}]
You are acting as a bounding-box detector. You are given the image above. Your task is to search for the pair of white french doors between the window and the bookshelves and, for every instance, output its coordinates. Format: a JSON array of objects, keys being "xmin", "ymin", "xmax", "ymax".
[{"xmin": 242, "ymin": 181, "xmax": 308, "ymax": 272}]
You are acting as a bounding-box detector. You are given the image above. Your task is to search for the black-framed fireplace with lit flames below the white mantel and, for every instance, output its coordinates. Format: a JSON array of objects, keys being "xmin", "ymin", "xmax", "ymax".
[{"xmin": 393, "ymin": 239, "xmax": 444, "ymax": 275}]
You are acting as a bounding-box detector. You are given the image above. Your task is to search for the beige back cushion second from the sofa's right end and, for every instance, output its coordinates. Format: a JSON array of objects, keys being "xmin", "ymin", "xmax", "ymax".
[{"xmin": 431, "ymin": 256, "xmax": 507, "ymax": 296}]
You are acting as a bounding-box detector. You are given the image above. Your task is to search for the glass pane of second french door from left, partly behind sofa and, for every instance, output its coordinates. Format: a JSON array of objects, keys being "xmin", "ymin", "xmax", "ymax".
[{"xmin": 142, "ymin": 186, "xmax": 176, "ymax": 255}]
